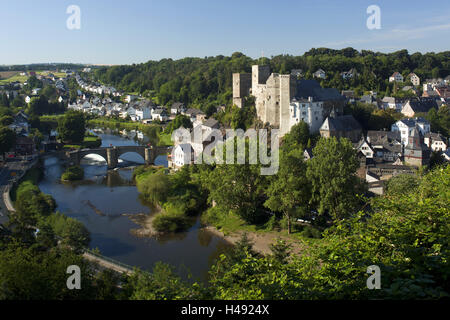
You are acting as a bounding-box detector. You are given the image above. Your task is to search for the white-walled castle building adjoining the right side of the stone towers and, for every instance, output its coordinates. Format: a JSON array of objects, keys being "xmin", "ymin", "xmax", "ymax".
[{"xmin": 289, "ymin": 97, "xmax": 323, "ymax": 133}]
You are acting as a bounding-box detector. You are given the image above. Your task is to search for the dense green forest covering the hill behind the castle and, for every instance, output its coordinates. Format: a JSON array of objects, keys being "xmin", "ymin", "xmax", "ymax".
[{"xmin": 92, "ymin": 48, "xmax": 450, "ymax": 109}]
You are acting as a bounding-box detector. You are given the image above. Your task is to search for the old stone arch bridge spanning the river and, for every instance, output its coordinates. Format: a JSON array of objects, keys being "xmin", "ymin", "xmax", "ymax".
[{"xmin": 66, "ymin": 146, "xmax": 171, "ymax": 169}]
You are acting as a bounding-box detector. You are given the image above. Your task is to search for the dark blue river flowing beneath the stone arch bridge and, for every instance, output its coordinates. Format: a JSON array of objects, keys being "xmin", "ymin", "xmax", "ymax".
[{"xmin": 39, "ymin": 129, "xmax": 229, "ymax": 280}]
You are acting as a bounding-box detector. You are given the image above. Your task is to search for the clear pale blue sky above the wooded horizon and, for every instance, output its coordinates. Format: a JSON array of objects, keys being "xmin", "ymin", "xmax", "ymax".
[{"xmin": 0, "ymin": 0, "xmax": 450, "ymax": 65}]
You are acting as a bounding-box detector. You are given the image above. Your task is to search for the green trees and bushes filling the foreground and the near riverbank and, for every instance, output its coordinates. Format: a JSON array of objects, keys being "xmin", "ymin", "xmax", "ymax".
[{"xmin": 0, "ymin": 122, "xmax": 450, "ymax": 299}]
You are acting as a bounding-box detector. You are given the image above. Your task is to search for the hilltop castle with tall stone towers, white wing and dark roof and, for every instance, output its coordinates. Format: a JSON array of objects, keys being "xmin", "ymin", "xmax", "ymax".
[{"xmin": 233, "ymin": 65, "xmax": 345, "ymax": 136}]
